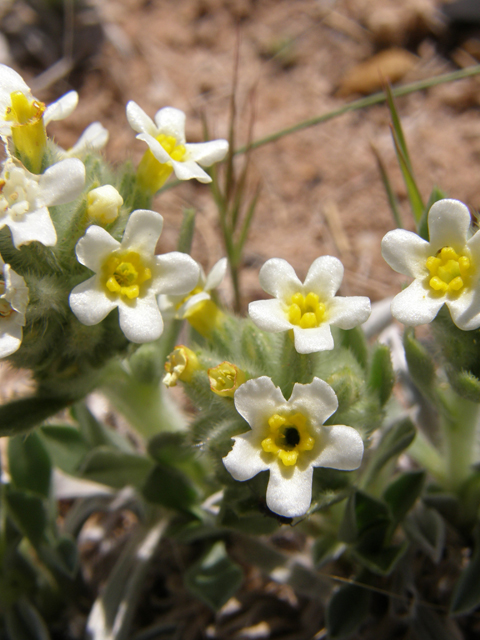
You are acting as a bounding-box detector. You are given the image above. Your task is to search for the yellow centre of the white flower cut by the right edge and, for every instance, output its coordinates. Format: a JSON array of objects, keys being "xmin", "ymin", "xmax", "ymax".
[{"xmin": 425, "ymin": 247, "xmax": 474, "ymax": 294}]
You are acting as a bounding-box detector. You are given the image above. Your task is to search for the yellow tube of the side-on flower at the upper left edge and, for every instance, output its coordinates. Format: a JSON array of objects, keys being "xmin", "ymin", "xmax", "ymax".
[{"xmin": 5, "ymin": 91, "xmax": 47, "ymax": 173}]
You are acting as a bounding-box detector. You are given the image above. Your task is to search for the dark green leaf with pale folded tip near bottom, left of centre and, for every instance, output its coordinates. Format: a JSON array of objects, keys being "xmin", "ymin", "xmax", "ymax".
[{"xmin": 185, "ymin": 541, "xmax": 243, "ymax": 611}]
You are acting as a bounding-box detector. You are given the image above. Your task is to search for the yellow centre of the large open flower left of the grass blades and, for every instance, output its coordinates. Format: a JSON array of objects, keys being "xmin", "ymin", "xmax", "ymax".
[{"xmin": 103, "ymin": 251, "xmax": 152, "ymax": 300}]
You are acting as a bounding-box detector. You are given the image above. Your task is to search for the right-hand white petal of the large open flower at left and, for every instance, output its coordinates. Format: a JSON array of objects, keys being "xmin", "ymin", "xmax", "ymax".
[{"xmin": 152, "ymin": 251, "xmax": 198, "ymax": 295}]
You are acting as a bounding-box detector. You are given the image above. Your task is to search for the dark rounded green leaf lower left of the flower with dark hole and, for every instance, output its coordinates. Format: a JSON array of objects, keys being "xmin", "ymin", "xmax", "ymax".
[{"xmin": 142, "ymin": 464, "xmax": 197, "ymax": 511}]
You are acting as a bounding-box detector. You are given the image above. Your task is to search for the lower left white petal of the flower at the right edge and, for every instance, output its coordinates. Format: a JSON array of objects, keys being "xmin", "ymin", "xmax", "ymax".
[{"xmin": 391, "ymin": 280, "xmax": 445, "ymax": 327}]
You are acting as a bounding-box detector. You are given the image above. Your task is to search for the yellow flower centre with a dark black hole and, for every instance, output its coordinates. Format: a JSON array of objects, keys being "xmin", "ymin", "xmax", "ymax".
[{"xmin": 262, "ymin": 413, "xmax": 315, "ymax": 467}]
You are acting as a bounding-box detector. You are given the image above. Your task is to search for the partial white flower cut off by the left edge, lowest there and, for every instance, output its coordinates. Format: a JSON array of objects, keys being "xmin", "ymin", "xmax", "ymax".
[{"xmin": 0, "ymin": 256, "xmax": 28, "ymax": 358}]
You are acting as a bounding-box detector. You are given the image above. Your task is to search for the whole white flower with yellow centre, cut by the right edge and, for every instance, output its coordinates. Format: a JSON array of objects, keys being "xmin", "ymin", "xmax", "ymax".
[{"xmin": 382, "ymin": 200, "xmax": 480, "ymax": 331}]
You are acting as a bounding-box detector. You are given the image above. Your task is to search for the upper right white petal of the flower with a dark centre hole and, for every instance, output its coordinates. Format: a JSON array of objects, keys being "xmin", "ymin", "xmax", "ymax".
[{"xmin": 288, "ymin": 378, "xmax": 338, "ymax": 427}]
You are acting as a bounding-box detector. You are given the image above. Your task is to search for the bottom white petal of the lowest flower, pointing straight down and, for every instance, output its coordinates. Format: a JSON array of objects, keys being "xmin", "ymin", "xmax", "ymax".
[{"xmin": 267, "ymin": 462, "xmax": 313, "ymax": 518}]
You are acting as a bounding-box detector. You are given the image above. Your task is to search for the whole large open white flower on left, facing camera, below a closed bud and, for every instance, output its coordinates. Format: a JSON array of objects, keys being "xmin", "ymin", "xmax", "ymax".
[{"xmin": 70, "ymin": 209, "xmax": 198, "ymax": 343}]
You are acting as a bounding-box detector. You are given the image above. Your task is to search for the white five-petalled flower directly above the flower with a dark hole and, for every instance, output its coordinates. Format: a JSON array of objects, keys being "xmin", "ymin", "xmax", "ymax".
[{"xmin": 248, "ymin": 256, "xmax": 370, "ymax": 353}]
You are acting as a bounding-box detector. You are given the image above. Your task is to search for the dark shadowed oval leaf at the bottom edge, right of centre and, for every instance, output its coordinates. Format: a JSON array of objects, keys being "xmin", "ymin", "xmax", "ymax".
[{"xmin": 326, "ymin": 584, "xmax": 371, "ymax": 640}]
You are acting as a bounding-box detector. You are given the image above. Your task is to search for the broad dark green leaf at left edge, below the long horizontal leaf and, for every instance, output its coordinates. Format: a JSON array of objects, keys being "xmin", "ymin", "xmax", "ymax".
[{"xmin": 8, "ymin": 432, "xmax": 52, "ymax": 498}]
